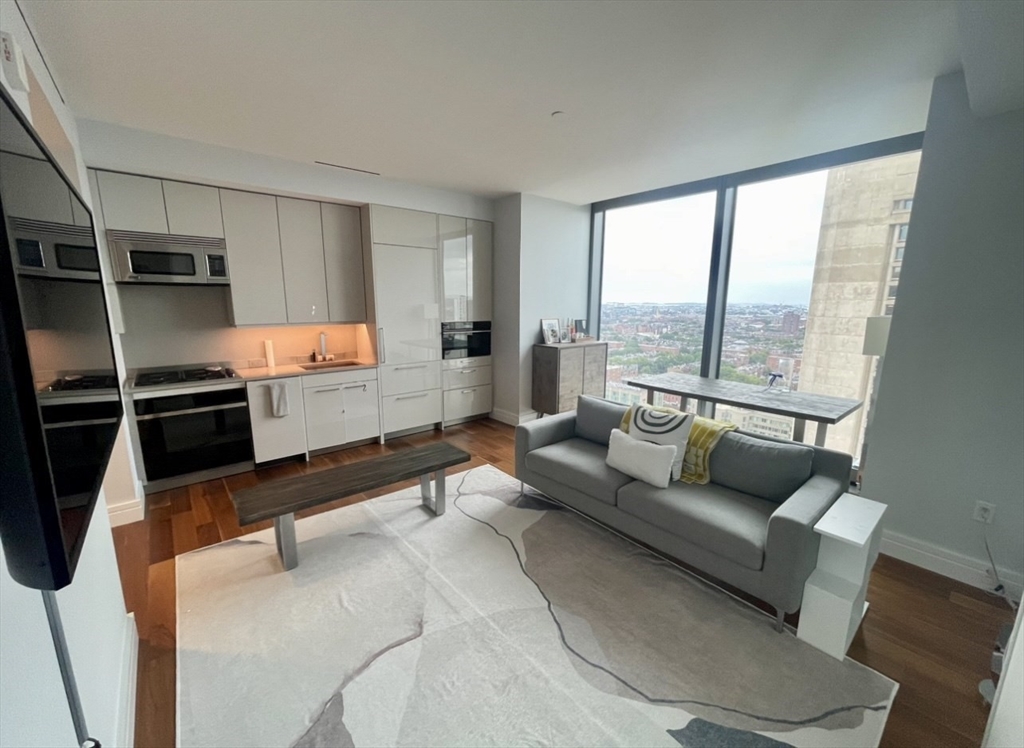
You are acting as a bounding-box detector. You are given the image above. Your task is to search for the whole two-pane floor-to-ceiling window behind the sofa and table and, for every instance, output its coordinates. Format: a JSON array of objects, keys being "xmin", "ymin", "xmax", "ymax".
[{"xmin": 595, "ymin": 137, "xmax": 920, "ymax": 456}]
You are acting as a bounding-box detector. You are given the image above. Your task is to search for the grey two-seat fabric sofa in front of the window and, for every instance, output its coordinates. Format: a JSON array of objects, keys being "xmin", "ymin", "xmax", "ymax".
[{"xmin": 515, "ymin": 397, "xmax": 852, "ymax": 630}]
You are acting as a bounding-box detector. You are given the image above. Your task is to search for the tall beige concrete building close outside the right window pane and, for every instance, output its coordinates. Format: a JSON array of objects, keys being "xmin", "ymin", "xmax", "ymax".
[{"xmin": 798, "ymin": 153, "xmax": 921, "ymax": 457}]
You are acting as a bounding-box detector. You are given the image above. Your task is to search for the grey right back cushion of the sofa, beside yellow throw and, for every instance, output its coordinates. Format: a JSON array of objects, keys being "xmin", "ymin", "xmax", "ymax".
[{"xmin": 710, "ymin": 431, "xmax": 814, "ymax": 504}]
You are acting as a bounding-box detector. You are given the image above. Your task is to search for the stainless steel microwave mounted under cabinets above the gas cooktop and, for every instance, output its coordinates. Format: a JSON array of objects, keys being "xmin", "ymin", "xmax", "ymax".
[{"xmin": 106, "ymin": 231, "xmax": 230, "ymax": 285}]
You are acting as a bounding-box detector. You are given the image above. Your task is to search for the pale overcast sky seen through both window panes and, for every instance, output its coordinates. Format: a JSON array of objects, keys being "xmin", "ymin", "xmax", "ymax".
[{"xmin": 602, "ymin": 170, "xmax": 828, "ymax": 305}]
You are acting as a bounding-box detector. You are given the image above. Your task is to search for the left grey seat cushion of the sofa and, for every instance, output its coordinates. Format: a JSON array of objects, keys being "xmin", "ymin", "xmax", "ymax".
[{"xmin": 526, "ymin": 439, "xmax": 633, "ymax": 506}]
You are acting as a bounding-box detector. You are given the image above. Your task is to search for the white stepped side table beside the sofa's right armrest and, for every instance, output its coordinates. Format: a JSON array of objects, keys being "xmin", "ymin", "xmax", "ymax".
[{"xmin": 797, "ymin": 494, "xmax": 887, "ymax": 660}]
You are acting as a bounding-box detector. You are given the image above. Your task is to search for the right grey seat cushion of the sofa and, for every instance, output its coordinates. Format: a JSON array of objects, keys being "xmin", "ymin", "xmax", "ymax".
[{"xmin": 617, "ymin": 481, "xmax": 778, "ymax": 570}]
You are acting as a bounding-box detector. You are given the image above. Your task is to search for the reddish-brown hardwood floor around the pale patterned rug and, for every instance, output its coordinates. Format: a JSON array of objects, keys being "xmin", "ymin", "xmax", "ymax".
[{"xmin": 114, "ymin": 420, "xmax": 1013, "ymax": 748}]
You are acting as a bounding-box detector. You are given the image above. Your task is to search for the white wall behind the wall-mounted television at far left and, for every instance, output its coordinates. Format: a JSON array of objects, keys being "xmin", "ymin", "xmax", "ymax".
[{"xmin": 0, "ymin": 0, "xmax": 136, "ymax": 746}]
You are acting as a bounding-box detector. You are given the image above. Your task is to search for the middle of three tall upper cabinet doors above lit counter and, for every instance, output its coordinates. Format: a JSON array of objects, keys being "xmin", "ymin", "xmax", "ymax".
[{"xmin": 278, "ymin": 198, "xmax": 329, "ymax": 324}]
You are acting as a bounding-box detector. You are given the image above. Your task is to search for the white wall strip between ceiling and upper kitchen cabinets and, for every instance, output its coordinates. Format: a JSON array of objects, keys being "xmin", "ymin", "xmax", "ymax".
[{"xmin": 78, "ymin": 120, "xmax": 494, "ymax": 220}]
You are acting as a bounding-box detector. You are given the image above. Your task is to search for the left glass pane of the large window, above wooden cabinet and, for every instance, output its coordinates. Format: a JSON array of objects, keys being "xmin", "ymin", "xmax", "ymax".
[{"xmin": 600, "ymin": 192, "xmax": 715, "ymax": 405}]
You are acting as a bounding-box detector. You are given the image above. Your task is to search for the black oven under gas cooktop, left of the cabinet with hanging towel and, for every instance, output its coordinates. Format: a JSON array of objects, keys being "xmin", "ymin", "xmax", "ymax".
[{"xmin": 134, "ymin": 387, "xmax": 253, "ymax": 493}]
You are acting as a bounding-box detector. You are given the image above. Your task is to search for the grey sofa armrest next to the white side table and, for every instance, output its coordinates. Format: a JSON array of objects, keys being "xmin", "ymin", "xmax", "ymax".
[{"xmin": 764, "ymin": 474, "xmax": 849, "ymax": 613}]
